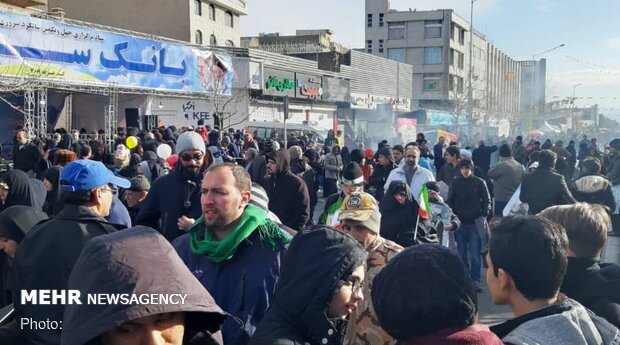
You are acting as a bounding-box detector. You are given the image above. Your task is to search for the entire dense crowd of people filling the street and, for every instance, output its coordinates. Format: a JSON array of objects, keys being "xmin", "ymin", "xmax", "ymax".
[{"xmin": 0, "ymin": 122, "xmax": 620, "ymax": 345}]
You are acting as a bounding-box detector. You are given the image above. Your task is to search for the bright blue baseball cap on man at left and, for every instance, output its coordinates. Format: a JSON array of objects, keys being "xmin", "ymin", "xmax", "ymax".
[{"xmin": 60, "ymin": 159, "xmax": 131, "ymax": 192}]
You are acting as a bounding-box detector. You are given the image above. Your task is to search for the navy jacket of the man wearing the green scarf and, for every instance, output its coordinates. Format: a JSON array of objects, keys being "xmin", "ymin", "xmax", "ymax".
[{"xmin": 172, "ymin": 224, "xmax": 286, "ymax": 345}]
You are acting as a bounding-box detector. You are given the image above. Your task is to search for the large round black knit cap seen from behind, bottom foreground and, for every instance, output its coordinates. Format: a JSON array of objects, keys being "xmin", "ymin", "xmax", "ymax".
[{"xmin": 371, "ymin": 244, "xmax": 478, "ymax": 340}]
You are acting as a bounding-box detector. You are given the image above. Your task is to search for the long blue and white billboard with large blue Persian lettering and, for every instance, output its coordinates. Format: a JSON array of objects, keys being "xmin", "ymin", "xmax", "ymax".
[{"xmin": 0, "ymin": 11, "xmax": 234, "ymax": 95}]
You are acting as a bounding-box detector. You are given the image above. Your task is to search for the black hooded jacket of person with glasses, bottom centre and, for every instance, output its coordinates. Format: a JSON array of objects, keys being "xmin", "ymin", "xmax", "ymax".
[{"xmin": 250, "ymin": 225, "xmax": 368, "ymax": 345}]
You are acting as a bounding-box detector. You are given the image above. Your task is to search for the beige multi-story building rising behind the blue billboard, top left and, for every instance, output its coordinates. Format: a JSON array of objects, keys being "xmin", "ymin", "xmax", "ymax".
[{"xmin": 44, "ymin": 0, "xmax": 248, "ymax": 47}]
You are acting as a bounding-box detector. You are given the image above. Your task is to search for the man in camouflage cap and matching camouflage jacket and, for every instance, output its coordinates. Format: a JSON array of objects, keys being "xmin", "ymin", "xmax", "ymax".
[{"xmin": 338, "ymin": 192, "xmax": 403, "ymax": 344}]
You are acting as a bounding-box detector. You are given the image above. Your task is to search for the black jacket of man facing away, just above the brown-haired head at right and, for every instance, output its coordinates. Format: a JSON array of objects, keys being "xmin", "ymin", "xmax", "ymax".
[{"xmin": 520, "ymin": 168, "xmax": 577, "ymax": 214}]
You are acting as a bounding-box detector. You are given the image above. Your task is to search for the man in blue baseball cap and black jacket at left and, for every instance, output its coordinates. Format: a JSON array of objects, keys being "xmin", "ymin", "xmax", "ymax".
[{"xmin": 13, "ymin": 160, "xmax": 130, "ymax": 344}]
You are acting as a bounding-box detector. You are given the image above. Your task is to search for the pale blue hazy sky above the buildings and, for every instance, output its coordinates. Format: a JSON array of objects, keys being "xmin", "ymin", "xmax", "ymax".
[{"xmin": 241, "ymin": 0, "xmax": 620, "ymax": 120}]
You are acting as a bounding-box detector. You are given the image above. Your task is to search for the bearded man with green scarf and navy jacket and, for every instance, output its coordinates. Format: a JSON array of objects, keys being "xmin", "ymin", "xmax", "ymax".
[{"xmin": 173, "ymin": 163, "xmax": 291, "ymax": 345}]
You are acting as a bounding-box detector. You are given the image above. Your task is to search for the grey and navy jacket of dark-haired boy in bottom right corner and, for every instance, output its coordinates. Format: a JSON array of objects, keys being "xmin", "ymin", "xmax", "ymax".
[{"xmin": 491, "ymin": 297, "xmax": 620, "ymax": 345}]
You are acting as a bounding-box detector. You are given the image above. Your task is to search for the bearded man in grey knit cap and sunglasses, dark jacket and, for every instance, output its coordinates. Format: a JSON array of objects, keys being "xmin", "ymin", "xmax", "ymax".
[{"xmin": 136, "ymin": 132, "xmax": 212, "ymax": 242}]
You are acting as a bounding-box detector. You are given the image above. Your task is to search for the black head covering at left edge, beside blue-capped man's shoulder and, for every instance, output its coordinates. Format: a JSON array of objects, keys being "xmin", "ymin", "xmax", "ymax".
[{"xmin": 0, "ymin": 205, "xmax": 48, "ymax": 243}]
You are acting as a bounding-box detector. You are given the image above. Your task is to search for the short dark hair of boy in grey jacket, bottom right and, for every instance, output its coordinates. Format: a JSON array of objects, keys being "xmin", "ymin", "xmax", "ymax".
[{"xmin": 489, "ymin": 216, "xmax": 568, "ymax": 301}]
